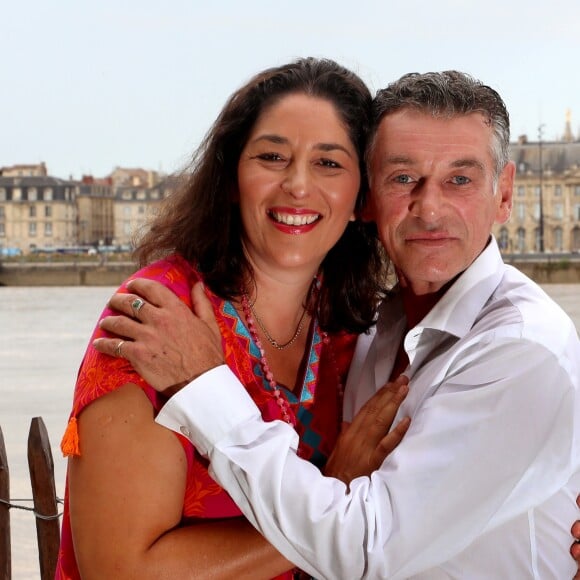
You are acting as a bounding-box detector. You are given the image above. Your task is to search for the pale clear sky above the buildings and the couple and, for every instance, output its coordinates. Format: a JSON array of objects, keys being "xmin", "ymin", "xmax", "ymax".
[{"xmin": 0, "ymin": 0, "xmax": 580, "ymax": 178}]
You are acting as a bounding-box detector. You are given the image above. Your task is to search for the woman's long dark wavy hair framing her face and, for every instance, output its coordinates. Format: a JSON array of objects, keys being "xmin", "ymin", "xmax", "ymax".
[{"xmin": 135, "ymin": 58, "xmax": 385, "ymax": 332}]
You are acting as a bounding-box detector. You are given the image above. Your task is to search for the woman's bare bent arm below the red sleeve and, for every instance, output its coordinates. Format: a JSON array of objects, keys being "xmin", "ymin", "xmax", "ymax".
[{"xmin": 69, "ymin": 384, "xmax": 292, "ymax": 579}]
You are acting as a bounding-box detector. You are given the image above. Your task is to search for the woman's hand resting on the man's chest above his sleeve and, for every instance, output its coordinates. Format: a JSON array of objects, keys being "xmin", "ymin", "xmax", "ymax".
[{"xmin": 324, "ymin": 375, "xmax": 411, "ymax": 484}]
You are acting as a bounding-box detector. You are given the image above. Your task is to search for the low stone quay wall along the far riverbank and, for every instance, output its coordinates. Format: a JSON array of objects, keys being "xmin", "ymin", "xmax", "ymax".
[{"xmin": 0, "ymin": 259, "xmax": 580, "ymax": 286}]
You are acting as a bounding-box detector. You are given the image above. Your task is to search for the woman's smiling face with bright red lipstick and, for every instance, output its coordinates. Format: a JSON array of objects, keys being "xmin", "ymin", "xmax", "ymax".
[{"xmin": 238, "ymin": 93, "xmax": 361, "ymax": 284}]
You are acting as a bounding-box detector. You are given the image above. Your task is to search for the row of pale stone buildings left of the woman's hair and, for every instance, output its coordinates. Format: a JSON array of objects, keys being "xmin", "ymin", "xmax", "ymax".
[{"xmin": 0, "ymin": 163, "xmax": 175, "ymax": 256}]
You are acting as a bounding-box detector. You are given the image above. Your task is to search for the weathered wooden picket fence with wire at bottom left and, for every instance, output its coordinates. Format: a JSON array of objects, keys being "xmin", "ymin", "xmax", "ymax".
[{"xmin": 0, "ymin": 417, "xmax": 60, "ymax": 580}]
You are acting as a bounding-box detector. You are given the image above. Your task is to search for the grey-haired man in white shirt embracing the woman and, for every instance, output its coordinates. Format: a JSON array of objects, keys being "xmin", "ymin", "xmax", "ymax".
[{"xmin": 105, "ymin": 72, "xmax": 580, "ymax": 580}]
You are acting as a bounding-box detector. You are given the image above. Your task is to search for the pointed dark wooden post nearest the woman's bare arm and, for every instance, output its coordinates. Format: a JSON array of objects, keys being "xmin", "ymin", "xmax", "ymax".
[{"xmin": 28, "ymin": 417, "xmax": 60, "ymax": 580}]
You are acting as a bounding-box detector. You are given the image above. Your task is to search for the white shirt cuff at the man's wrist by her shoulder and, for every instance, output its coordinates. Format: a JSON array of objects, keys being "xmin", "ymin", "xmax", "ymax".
[{"xmin": 155, "ymin": 365, "xmax": 260, "ymax": 457}]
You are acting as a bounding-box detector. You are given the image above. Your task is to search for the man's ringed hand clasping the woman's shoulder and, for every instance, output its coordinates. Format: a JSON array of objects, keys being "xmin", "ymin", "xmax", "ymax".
[{"xmin": 93, "ymin": 279, "xmax": 224, "ymax": 395}]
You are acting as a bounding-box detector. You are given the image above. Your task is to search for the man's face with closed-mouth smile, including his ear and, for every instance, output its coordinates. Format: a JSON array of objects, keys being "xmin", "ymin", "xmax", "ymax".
[{"xmin": 369, "ymin": 109, "xmax": 514, "ymax": 295}]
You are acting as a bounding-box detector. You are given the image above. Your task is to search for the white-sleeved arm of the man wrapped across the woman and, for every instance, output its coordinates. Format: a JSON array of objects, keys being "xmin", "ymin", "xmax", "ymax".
[{"xmin": 159, "ymin": 341, "xmax": 577, "ymax": 578}]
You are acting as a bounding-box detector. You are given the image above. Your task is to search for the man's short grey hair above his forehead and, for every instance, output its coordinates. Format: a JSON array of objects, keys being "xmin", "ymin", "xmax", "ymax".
[{"xmin": 366, "ymin": 70, "xmax": 510, "ymax": 181}]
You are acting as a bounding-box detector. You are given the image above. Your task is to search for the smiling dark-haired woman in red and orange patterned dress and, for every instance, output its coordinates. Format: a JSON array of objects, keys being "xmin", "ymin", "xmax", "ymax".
[{"xmin": 57, "ymin": 59, "xmax": 404, "ymax": 578}]
